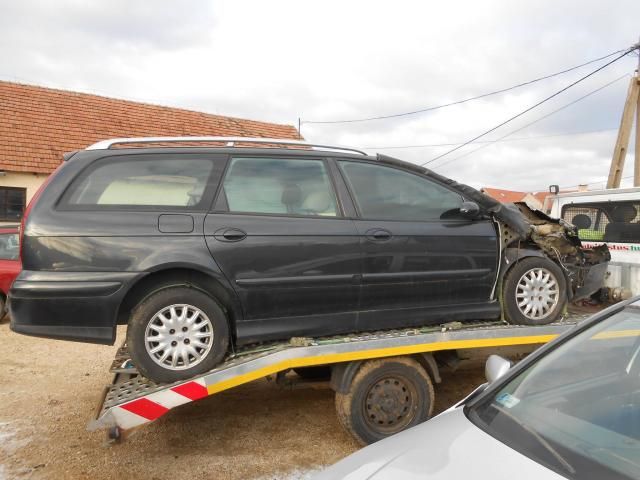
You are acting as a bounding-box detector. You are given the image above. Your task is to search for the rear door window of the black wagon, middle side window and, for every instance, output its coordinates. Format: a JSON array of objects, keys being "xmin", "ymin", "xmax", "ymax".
[{"xmin": 221, "ymin": 157, "xmax": 338, "ymax": 217}]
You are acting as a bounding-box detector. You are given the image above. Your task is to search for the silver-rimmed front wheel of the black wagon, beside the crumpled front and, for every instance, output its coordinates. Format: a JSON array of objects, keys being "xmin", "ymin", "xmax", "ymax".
[{"xmin": 502, "ymin": 257, "xmax": 567, "ymax": 325}]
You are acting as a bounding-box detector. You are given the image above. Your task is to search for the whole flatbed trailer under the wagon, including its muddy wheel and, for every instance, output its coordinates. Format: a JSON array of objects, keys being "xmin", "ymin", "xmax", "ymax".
[{"xmin": 88, "ymin": 314, "xmax": 586, "ymax": 444}]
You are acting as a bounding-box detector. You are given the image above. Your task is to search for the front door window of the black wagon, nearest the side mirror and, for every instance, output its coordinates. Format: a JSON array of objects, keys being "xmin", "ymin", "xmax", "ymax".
[{"xmin": 340, "ymin": 162, "xmax": 462, "ymax": 221}]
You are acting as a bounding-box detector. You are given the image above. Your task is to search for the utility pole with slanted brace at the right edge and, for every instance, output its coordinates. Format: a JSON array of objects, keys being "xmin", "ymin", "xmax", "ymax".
[{"xmin": 607, "ymin": 38, "xmax": 640, "ymax": 188}]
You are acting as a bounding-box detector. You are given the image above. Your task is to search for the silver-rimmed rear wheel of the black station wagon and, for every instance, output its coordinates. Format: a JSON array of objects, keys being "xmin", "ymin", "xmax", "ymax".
[{"xmin": 127, "ymin": 286, "xmax": 229, "ymax": 383}]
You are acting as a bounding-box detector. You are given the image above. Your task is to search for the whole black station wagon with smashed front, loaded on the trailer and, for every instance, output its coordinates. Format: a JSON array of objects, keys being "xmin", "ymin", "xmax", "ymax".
[{"xmin": 10, "ymin": 137, "xmax": 609, "ymax": 382}]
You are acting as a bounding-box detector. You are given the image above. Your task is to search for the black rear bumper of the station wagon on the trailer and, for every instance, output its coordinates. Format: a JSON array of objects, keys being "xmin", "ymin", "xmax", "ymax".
[{"xmin": 9, "ymin": 271, "xmax": 140, "ymax": 345}]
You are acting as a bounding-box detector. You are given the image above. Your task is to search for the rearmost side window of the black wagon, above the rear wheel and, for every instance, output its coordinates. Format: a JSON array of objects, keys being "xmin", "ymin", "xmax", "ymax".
[{"xmin": 63, "ymin": 156, "xmax": 213, "ymax": 209}]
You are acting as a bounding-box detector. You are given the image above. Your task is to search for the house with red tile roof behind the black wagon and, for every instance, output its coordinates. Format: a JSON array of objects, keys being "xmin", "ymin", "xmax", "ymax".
[{"xmin": 0, "ymin": 81, "xmax": 301, "ymax": 223}]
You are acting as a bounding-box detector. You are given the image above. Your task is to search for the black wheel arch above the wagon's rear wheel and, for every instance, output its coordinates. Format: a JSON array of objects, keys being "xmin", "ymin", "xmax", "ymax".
[{"xmin": 116, "ymin": 264, "xmax": 242, "ymax": 339}]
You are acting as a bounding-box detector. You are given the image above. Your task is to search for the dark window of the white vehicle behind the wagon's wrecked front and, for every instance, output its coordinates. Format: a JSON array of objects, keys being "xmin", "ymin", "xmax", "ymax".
[{"xmin": 562, "ymin": 201, "xmax": 640, "ymax": 243}]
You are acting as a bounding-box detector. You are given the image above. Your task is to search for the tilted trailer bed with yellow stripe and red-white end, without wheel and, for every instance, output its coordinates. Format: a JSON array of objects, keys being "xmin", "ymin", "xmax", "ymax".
[{"xmin": 88, "ymin": 316, "xmax": 586, "ymax": 432}]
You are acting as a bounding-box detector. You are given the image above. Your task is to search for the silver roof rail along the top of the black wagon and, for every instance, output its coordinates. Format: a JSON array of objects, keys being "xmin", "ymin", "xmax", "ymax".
[{"xmin": 85, "ymin": 137, "xmax": 368, "ymax": 155}]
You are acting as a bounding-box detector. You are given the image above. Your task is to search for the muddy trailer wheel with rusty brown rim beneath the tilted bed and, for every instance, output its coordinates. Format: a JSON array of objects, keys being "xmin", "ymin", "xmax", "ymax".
[{"xmin": 336, "ymin": 357, "xmax": 435, "ymax": 445}]
